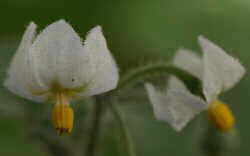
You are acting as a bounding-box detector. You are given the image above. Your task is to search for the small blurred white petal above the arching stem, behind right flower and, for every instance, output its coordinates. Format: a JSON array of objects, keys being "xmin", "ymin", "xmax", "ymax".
[{"xmin": 173, "ymin": 49, "xmax": 203, "ymax": 79}]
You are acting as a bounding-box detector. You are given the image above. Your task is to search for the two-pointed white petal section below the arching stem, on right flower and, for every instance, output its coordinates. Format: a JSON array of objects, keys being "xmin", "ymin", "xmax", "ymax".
[{"xmin": 145, "ymin": 77, "xmax": 207, "ymax": 131}]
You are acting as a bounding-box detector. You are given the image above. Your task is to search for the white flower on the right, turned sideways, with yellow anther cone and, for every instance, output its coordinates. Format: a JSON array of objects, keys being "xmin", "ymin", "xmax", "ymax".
[{"xmin": 145, "ymin": 36, "xmax": 245, "ymax": 132}]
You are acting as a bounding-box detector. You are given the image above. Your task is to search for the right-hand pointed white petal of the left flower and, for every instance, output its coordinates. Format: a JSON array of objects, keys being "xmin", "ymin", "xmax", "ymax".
[{"xmin": 79, "ymin": 26, "xmax": 119, "ymax": 95}]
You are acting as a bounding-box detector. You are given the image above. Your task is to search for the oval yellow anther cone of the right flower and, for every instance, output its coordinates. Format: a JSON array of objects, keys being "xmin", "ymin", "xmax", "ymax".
[{"xmin": 208, "ymin": 100, "xmax": 235, "ymax": 132}]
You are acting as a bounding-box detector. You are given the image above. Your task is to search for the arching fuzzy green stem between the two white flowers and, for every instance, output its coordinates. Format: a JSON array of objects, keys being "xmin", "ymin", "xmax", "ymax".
[{"xmin": 115, "ymin": 63, "xmax": 203, "ymax": 97}]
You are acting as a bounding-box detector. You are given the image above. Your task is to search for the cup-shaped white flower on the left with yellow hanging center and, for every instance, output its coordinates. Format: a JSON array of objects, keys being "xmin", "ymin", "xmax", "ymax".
[{"xmin": 4, "ymin": 20, "xmax": 119, "ymax": 134}]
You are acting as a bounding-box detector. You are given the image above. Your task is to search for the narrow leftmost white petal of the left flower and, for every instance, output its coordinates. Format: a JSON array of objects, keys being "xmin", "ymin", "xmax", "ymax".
[{"xmin": 4, "ymin": 22, "xmax": 47, "ymax": 102}]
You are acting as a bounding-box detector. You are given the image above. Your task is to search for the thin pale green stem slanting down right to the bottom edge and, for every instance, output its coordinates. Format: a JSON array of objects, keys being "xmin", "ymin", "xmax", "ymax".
[{"xmin": 110, "ymin": 103, "xmax": 136, "ymax": 156}]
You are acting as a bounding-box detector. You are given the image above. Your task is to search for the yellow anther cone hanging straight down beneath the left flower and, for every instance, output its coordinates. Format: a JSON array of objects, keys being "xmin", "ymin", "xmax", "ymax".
[{"xmin": 52, "ymin": 93, "xmax": 74, "ymax": 135}]
